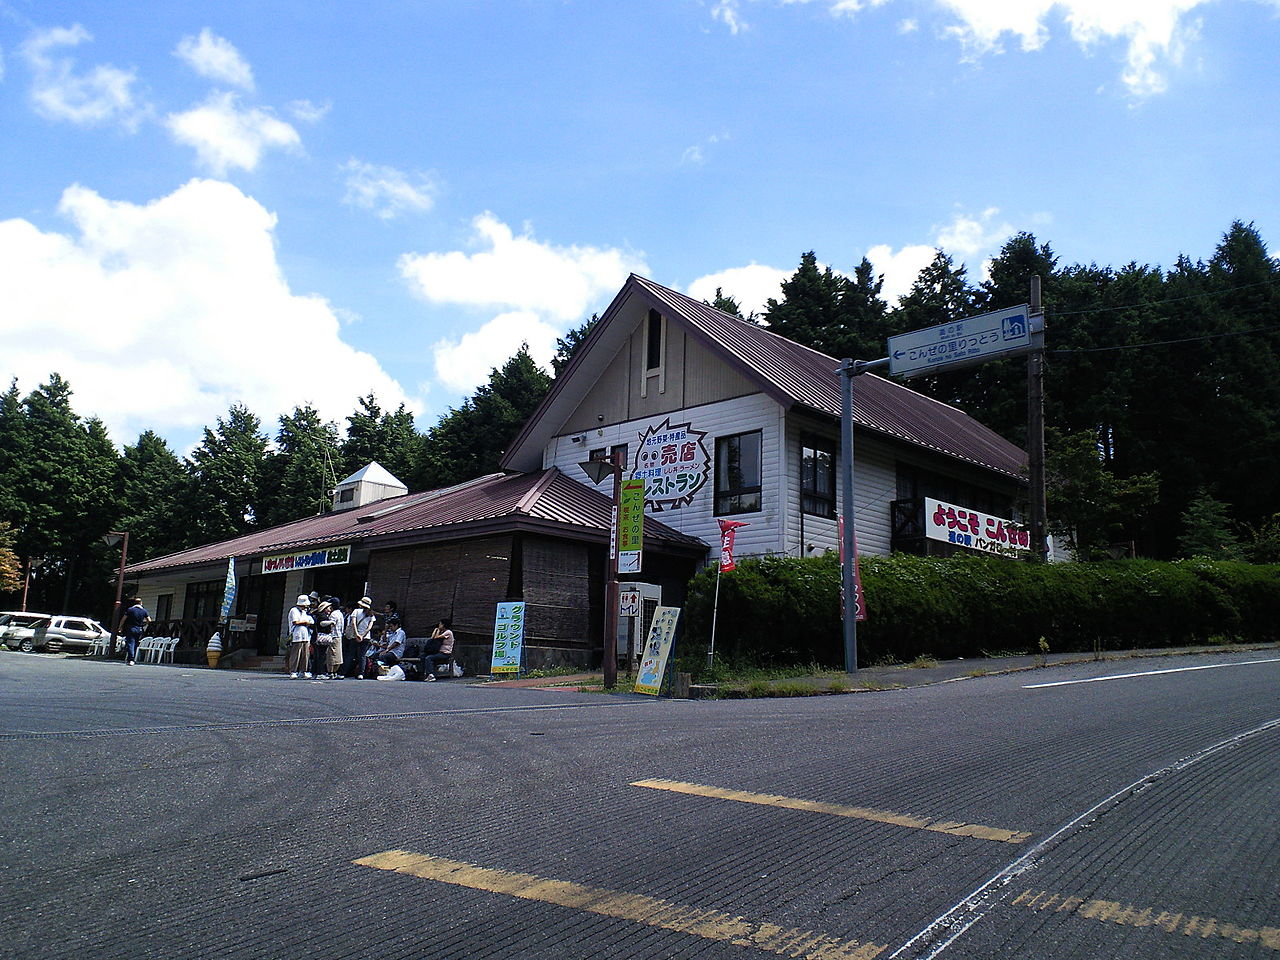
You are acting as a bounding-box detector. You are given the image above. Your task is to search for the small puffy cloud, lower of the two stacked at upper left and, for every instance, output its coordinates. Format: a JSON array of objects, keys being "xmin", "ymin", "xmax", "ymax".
[{"xmin": 165, "ymin": 91, "xmax": 302, "ymax": 177}]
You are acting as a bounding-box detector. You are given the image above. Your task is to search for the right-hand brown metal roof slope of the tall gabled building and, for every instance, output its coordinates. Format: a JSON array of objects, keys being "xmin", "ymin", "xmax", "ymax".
[{"xmin": 627, "ymin": 274, "xmax": 1027, "ymax": 480}]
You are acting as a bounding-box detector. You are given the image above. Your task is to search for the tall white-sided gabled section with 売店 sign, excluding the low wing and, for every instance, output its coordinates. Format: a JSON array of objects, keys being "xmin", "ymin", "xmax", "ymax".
[{"xmin": 502, "ymin": 275, "xmax": 1027, "ymax": 557}]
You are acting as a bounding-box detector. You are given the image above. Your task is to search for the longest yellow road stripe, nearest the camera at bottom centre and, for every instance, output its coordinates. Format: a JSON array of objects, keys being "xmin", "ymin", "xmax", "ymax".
[{"xmin": 353, "ymin": 850, "xmax": 884, "ymax": 960}]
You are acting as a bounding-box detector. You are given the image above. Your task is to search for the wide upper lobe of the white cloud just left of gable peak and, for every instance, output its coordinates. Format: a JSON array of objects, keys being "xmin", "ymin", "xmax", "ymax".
[{"xmin": 399, "ymin": 212, "xmax": 645, "ymax": 323}]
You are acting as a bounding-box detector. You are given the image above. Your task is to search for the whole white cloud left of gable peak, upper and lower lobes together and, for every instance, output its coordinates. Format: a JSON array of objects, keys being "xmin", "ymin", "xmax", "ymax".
[{"xmin": 399, "ymin": 212, "xmax": 648, "ymax": 392}]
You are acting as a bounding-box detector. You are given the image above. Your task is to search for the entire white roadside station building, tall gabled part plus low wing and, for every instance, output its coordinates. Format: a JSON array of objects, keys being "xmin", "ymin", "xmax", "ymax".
[{"xmin": 128, "ymin": 275, "xmax": 1025, "ymax": 668}]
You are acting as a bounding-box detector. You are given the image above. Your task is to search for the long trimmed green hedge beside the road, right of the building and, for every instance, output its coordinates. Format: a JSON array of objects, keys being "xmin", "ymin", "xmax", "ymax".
[{"xmin": 682, "ymin": 554, "xmax": 1280, "ymax": 667}]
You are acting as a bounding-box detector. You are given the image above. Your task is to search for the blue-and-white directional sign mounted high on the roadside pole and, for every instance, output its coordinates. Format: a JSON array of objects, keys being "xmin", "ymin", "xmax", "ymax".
[{"xmin": 888, "ymin": 303, "xmax": 1044, "ymax": 376}]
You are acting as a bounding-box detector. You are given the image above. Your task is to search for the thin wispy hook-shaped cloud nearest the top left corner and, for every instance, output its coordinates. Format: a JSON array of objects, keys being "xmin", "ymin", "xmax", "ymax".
[{"xmin": 20, "ymin": 23, "xmax": 148, "ymax": 131}]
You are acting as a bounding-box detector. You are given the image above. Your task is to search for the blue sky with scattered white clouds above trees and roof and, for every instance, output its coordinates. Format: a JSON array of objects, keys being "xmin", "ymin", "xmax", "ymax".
[{"xmin": 0, "ymin": 0, "xmax": 1280, "ymax": 452}]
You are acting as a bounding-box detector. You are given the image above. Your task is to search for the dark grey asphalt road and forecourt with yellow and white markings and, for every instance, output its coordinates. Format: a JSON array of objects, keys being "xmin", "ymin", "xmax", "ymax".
[{"xmin": 0, "ymin": 650, "xmax": 1280, "ymax": 960}]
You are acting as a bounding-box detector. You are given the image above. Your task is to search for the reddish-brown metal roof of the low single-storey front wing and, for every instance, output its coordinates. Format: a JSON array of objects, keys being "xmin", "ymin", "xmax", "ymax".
[{"xmin": 127, "ymin": 467, "xmax": 707, "ymax": 576}]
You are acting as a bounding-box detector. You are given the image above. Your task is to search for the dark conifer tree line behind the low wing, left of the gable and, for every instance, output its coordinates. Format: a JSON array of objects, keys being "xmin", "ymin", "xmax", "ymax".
[{"xmin": 0, "ymin": 347, "xmax": 552, "ymax": 613}]
